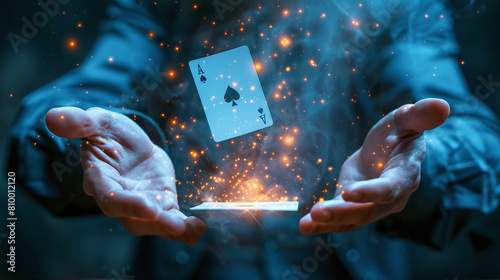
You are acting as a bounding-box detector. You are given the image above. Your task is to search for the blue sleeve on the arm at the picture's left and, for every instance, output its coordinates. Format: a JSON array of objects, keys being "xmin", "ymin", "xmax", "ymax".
[{"xmin": 9, "ymin": 0, "xmax": 166, "ymax": 215}]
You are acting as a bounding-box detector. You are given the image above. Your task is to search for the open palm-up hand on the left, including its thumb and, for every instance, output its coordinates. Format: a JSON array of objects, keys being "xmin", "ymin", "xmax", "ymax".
[{"xmin": 46, "ymin": 107, "xmax": 206, "ymax": 245}]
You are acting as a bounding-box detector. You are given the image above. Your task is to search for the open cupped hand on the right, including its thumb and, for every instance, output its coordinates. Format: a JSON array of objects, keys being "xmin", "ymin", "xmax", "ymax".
[{"xmin": 299, "ymin": 98, "xmax": 450, "ymax": 234}]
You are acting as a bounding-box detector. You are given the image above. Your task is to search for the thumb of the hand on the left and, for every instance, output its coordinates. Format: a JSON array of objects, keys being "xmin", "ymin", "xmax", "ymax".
[{"xmin": 45, "ymin": 107, "xmax": 109, "ymax": 139}]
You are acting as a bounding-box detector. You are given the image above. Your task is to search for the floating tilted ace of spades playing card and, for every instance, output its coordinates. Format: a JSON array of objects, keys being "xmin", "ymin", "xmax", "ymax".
[{"xmin": 189, "ymin": 46, "xmax": 273, "ymax": 142}]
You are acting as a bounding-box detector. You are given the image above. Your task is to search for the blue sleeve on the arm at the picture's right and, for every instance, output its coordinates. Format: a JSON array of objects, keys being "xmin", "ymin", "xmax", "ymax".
[{"xmin": 372, "ymin": 1, "xmax": 500, "ymax": 248}]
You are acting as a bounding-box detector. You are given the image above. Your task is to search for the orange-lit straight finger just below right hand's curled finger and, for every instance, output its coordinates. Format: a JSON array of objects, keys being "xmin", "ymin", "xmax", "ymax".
[{"xmin": 311, "ymin": 199, "xmax": 378, "ymax": 226}]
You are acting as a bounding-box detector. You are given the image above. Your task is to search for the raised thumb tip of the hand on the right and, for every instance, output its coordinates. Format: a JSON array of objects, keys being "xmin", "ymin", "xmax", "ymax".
[{"xmin": 394, "ymin": 98, "xmax": 450, "ymax": 137}]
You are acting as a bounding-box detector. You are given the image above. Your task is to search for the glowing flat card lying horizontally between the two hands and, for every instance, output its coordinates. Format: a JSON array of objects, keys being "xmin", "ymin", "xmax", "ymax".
[{"xmin": 190, "ymin": 201, "xmax": 299, "ymax": 211}]
